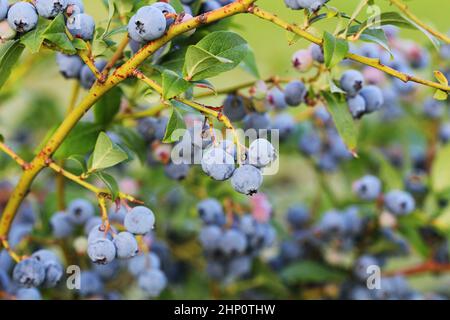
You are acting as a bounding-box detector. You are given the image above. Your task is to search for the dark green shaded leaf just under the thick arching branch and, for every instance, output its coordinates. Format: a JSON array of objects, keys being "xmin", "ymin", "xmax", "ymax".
[{"xmin": 94, "ymin": 87, "xmax": 122, "ymax": 127}]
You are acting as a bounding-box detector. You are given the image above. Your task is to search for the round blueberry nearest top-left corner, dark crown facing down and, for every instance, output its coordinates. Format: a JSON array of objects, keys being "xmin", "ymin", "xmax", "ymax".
[{"xmin": 8, "ymin": 1, "xmax": 39, "ymax": 33}]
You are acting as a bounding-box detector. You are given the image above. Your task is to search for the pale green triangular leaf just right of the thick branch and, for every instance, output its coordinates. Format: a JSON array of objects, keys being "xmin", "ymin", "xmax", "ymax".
[{"xmin": 89, "ymin": 132, "xmax": 128, "ymax": 172}]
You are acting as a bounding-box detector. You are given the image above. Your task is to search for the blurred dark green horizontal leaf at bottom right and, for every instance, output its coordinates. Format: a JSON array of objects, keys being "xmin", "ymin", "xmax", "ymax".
[{"xmin": 281, "ymin": 261, "xmax": 346, "ymax": 284}]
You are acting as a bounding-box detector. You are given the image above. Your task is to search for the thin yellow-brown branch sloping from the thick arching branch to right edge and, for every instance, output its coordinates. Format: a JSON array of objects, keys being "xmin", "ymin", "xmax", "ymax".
[{"xmin": 249, "ymin": 6, "xmax": 450, "ymax": 92}]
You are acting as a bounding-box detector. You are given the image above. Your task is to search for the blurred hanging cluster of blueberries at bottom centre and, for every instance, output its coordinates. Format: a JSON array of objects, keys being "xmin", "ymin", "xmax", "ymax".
[{"xmin": 197, "ymin": 198, "xmax": 276, "ymax": 283}]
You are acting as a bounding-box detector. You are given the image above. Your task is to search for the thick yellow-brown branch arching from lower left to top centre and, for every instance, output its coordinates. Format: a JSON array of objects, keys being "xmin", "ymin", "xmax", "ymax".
[{"xmin": 0, "ymin": 0, "xmax": 256, "ymax": 237}]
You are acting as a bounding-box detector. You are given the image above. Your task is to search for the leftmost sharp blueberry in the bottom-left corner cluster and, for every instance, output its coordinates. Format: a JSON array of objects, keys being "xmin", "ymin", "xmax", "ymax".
[{"xmin": 13, "ymin": 258, "xmax": 45, "ymax": 288}]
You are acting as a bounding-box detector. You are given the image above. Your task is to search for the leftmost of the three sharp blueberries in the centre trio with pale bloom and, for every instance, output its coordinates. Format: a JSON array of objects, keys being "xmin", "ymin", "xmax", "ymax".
[{"xmin": 202, "ymin": 148, "xmax": 235, "ymax": 181}]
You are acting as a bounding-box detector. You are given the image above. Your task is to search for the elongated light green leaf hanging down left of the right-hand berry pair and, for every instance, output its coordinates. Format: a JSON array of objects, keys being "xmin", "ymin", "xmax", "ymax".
[{"xmin": 322, "ymin": 91, "xmax": 358, "ymax": 154}]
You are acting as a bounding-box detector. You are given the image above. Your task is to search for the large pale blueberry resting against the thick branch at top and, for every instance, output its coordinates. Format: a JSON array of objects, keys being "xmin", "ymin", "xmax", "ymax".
[{"xmin": 128, "ymin": 6, "xmax": 167, "ymax": 43}]
